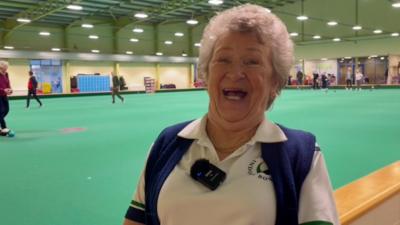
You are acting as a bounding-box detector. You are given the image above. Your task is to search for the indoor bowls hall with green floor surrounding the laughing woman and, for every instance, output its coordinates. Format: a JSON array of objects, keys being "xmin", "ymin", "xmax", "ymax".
[{"xmin": 0, "ymin": 0, "xmax": 400, "ymax": 225}]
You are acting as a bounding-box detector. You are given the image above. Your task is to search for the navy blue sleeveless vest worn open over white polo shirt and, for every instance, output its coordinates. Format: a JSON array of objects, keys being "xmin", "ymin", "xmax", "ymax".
[{"xmin": 143, "ymin": 121, "xmax": 315, "ymax": 225}]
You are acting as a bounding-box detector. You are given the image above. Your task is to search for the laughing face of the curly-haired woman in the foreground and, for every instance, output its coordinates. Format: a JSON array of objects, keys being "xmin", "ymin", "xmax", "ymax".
[{"xmin": 207, "ymin": 32, "xmax": 277, "ymax": 129}]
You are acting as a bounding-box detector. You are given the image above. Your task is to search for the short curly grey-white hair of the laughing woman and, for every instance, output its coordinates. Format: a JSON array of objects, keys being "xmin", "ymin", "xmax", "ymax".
[{"xmin": 197, "ymin": 4, "xmax": 294, "ymax": 94}]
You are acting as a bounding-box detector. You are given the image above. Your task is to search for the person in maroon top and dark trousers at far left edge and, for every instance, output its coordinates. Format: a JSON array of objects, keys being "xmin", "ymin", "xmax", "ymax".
[{"xmin": 0, "ymin": 61, "xmax": 12, "ymax": 135}]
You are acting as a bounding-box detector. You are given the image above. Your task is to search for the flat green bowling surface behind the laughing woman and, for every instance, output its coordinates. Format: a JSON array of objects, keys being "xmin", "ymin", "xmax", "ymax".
[{"xmin": 0, "ymin": 89, "xmax": 400, "ymax": 225}]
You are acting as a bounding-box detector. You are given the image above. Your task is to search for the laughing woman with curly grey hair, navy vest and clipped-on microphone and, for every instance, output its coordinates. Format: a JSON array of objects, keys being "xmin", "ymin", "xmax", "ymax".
[{"xmin": 124, "ymin": 4, "xmax": 338, "ymax": 225}]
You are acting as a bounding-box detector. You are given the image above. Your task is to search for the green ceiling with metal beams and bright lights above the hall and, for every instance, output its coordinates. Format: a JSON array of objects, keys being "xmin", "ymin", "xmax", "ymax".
[{"xmin": 0, "ymin": 0, "xmax": 400, "ymax": 45}]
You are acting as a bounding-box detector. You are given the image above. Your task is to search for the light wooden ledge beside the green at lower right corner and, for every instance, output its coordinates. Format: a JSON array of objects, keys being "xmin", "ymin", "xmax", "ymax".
[{"xmin": 335, "ymin": 161, "xmax": 400, "ymax": 225}]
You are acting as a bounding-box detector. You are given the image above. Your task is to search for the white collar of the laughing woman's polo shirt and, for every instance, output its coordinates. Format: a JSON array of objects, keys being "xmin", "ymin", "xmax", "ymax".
[{"xmin": 178, "ymin": 116, "xmax": 287, "ymax": 144}]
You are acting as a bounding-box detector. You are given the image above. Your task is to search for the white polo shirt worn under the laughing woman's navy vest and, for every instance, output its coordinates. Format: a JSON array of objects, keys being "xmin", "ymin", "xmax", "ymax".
[{"xmin": 131, "ymin": 117, "xmax": 339, "ymax": 225}]
